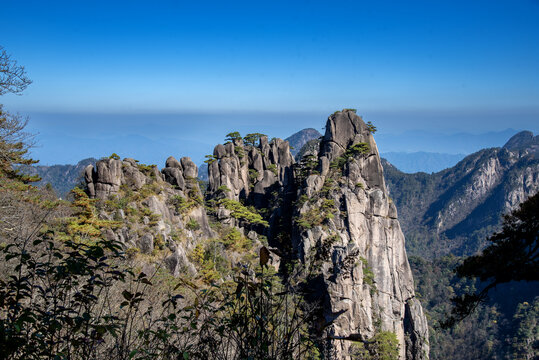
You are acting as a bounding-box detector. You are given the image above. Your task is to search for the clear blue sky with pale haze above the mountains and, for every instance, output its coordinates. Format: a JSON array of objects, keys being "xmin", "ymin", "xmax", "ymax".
[{"xmin": 0, "ymin": 0, "xmax": 539, "ymax": 163}]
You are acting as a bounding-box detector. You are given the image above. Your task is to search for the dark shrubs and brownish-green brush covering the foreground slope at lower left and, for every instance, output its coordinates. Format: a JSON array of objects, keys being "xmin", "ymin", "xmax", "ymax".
[{"xmin": 0, "ymin": 187, "xmax": 318, "ymax": 359}]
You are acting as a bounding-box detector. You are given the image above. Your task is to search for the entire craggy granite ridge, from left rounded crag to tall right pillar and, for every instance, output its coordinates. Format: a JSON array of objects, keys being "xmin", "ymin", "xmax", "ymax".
[{"xmin": 85, "ymin": 110, "xmax": 429, "ymax": 359}]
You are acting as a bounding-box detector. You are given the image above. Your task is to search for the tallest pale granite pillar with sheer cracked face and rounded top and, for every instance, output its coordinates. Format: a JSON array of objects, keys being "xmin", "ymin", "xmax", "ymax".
[{"xmin": 293, "ymin": 111, "xmax": 428, "ymax": 359}]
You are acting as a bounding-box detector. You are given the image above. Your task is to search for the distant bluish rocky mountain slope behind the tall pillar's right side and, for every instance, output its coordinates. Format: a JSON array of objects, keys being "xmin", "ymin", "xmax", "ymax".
[{"xmin": 384, "ymin": 131, "xmax": 539, "ymax": 257}]
